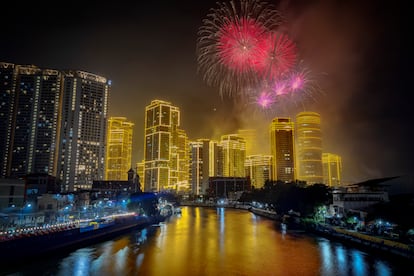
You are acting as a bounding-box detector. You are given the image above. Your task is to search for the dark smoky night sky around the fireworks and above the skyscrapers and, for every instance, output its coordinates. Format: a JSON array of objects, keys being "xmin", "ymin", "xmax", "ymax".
[{"xmin": 0, "ymin": 0, "xmax": 408, "ymax": 183}]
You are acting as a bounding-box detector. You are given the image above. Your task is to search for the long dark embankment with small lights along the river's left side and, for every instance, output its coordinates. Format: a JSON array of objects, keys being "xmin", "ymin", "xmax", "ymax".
[{"xmin": 0, "ymin": 214, "xmax": 156, "ymax": 264}]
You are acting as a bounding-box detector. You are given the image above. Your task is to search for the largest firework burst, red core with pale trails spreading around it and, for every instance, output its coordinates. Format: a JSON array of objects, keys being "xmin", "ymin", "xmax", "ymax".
[{"xmin": 197, "ymin": 0, "xmax": 283, "ymax": 96}]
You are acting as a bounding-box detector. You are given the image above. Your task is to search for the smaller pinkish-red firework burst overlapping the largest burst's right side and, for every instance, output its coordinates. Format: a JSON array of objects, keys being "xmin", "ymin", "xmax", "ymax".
[{"xmin": 256, "ymin": 32, "xmax": 297, "ymax": 79}]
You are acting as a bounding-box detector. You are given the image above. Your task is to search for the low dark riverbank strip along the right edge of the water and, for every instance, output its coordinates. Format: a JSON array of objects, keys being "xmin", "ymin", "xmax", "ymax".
[{"xmin": 180, "ymin": 201, "xmax": 414, "ymax": 260}]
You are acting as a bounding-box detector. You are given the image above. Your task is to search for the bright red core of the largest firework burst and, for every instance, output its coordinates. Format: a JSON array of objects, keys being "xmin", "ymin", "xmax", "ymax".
[{"xmin": 217, "ymin": 18, "xmax": 266, "ymax": 73}]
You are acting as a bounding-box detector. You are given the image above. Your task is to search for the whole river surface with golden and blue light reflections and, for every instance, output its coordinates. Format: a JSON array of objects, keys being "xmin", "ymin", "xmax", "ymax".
[{"xmin": 0, "ymin": 207, "xmax": 414, "ymax": 276}]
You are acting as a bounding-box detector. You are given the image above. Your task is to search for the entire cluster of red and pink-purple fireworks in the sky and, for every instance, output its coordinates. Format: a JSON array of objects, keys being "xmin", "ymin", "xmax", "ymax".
[{"xmin": 197, "ymin": 0, "xmax": 324, "ymax": 114}]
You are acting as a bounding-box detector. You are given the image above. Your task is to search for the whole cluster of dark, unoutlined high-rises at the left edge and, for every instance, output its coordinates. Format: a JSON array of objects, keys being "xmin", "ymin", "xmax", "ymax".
[{"xmin": 0, "ymin": 62, "xmax": 110, "ymax": 191}]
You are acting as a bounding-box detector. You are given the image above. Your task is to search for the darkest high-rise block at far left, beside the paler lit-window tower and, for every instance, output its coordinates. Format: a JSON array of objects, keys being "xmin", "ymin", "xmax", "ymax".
[{"xmin": 0, "ymin": 63, "xmax": 62, "ymax": 177}]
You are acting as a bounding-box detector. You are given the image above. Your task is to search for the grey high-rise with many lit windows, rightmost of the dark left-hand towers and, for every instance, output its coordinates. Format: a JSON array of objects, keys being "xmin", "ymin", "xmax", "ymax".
[{"xmin": 58, "ymin": 71, "xmax": 110, "ymax": 191}]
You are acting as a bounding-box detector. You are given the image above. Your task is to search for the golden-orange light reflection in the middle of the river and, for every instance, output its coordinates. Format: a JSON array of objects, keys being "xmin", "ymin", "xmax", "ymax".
[{"xmin": 137, "ymin": 207, "xmax": 320, "ymax": 275}]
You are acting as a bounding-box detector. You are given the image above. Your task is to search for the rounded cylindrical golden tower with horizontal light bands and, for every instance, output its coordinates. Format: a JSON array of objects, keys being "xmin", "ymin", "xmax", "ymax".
[{"xmin": 296, "ymin": 112, "xmax": 323, "ymax": 184}]
